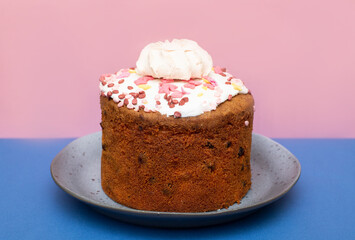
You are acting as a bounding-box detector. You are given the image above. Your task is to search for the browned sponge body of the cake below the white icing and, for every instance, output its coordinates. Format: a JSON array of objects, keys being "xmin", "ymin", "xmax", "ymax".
[{"xmin": 100, "ymin": 94, "xmax": 254, "ymax": 212}]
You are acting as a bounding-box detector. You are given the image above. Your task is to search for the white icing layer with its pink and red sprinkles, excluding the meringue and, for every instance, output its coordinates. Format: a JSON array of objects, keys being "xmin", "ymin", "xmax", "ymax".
[{"xmin": 100, "ymin": 67, "xmax": 248, "ymax": 117}]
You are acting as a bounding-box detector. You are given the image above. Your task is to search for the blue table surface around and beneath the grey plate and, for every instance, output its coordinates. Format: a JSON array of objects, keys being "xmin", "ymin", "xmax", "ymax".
[{"xmin": 0, "ymin": 139, "xmax": 355, "ymax": 239}]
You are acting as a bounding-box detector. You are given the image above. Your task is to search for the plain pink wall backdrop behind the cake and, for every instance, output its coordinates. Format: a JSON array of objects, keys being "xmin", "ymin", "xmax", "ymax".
[{"xmin": 0, "ymin": 0, "xmax": 355, "ymax": 138}]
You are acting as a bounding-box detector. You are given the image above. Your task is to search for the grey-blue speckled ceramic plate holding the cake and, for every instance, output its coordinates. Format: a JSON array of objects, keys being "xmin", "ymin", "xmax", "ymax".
[{"xmin": 51, "ymin": 132, "xmax": 301, "ymax": 228}]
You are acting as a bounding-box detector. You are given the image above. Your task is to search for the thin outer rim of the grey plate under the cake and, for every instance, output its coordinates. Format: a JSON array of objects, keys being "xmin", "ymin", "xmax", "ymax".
[{"xmin": 50, "ymin": 131, "xmax": 301, "ymax": 217}]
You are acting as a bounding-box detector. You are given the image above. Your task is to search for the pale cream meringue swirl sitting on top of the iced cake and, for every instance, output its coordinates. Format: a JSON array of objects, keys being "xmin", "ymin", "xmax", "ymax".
[{"xmin": 136, "ymin": 39, "xmax": 213, "ymax": 80}]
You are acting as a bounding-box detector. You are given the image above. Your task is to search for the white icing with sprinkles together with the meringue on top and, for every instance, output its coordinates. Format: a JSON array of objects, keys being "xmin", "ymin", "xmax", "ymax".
[{"xmin": 100, "ymin": 39, "xmax": 248, "ymax": 117}]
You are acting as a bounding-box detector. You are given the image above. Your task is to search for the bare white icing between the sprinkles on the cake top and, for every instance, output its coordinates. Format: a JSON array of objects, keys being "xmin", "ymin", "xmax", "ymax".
[{"xmin": 100, "ymin": 69, "xmax": 248, "ymax": 117}]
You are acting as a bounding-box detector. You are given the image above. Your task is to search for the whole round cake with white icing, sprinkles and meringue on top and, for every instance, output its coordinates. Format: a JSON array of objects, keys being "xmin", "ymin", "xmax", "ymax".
[{"xmin": 100, "ymin": 39, "xmax": 254, "ymax": 212}]
